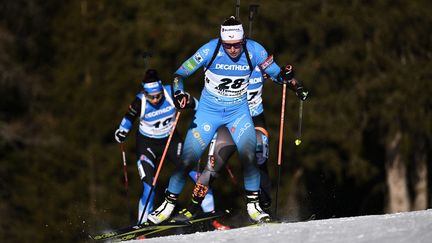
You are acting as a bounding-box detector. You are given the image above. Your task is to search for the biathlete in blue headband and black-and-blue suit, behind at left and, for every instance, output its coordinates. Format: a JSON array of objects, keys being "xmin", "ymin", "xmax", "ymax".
[{"xmin": 115, "ymin": 69, "xmax": 214, "ymax": 223}]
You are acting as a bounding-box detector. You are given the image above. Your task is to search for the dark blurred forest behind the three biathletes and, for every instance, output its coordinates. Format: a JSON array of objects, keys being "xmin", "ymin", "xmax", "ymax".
[{"xmin": 0, "ymin": 0, "xmax": 432, "ymax": 242}]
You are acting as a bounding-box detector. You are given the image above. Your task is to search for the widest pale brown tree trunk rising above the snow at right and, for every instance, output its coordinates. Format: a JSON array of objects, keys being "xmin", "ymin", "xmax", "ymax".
[{"xmin": 386, "ymin": 131, "xmax": 411, "ymax": 213}]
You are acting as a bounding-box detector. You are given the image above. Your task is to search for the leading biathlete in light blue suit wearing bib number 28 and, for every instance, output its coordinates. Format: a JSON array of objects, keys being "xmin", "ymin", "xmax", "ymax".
[{"xmin": 148, "ymin": 17, "xmax": 308, "ymax": 224}]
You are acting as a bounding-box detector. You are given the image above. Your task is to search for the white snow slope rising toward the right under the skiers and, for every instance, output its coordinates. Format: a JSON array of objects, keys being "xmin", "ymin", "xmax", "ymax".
[{"xmin": 130, "ymin": 209, "xmax": 432, "ymax": 243}]
